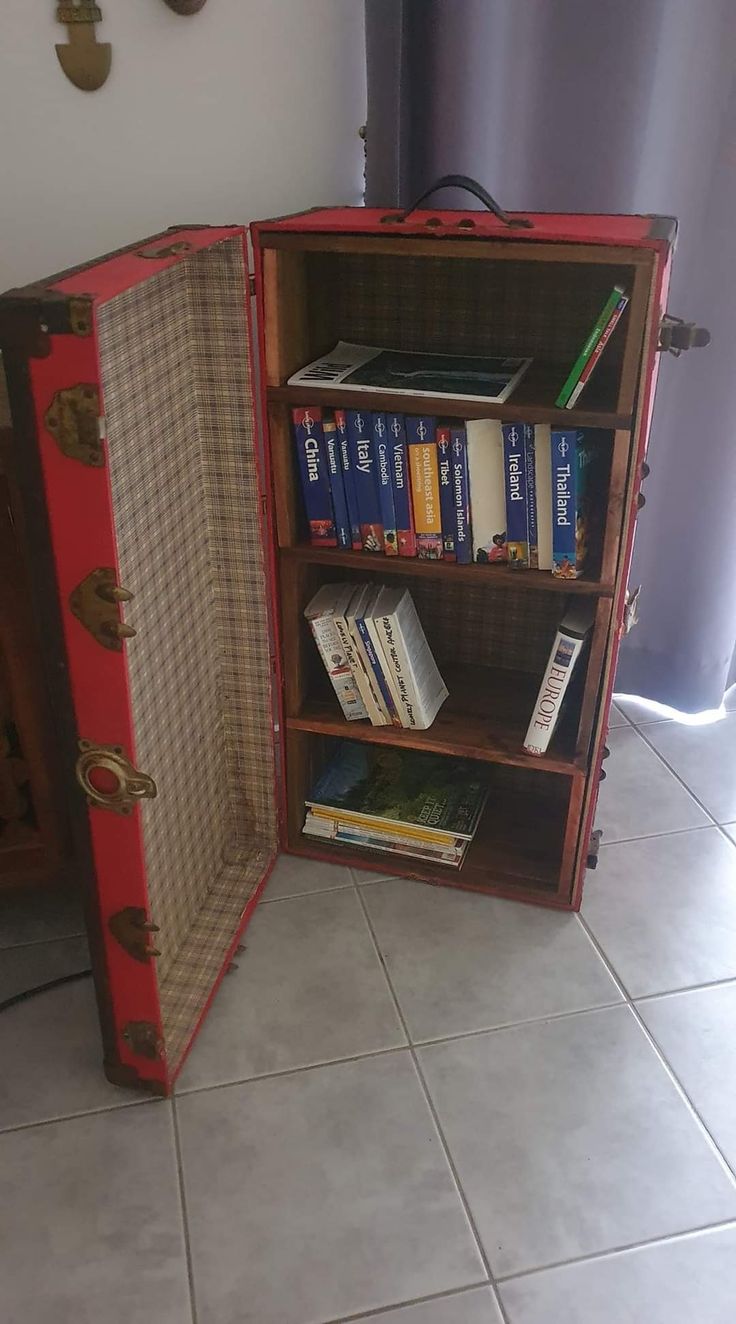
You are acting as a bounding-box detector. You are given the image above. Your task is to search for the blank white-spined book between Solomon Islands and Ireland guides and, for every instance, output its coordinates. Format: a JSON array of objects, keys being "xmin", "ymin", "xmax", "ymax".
[{"xmin": 465, "ymin": 418, "xmax": 508, "ymax": 564}]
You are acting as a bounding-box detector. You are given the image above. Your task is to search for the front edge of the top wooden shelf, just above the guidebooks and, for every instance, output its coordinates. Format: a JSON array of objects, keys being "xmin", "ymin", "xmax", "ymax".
[{"xmin": 267, "ymin": 387, "xmax": 631, "ymax": 430}]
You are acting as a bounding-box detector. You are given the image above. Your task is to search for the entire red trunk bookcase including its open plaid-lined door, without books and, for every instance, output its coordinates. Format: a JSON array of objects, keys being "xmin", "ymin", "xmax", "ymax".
[{"xmin": 0, "ymin": 208, "xmax": 674, "ymax": 1094}]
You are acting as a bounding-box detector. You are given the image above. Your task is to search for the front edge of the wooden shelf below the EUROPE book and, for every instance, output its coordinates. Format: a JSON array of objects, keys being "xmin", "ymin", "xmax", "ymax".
[{"xmin": 286, "ymin": 706, "xmax": 585, "ymax": 777}]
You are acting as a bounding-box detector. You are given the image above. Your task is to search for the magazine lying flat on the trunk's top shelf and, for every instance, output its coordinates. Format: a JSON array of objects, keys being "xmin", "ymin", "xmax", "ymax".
[{"xmin": 289, "ymin": 340, "xmax": 532, "ymax": 404}]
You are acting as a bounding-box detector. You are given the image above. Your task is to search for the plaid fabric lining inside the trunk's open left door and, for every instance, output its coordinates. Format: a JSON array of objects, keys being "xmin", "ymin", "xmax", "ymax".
[{"xmin": 98, "ymin": 240, "xmax": 277, "ymax": 1066}]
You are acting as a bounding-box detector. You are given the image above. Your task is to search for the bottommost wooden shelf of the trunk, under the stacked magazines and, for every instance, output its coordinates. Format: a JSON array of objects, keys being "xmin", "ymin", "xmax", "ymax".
[{"xmin": 289, "ymin": 773, "xmax": 568, "ymax": 907}]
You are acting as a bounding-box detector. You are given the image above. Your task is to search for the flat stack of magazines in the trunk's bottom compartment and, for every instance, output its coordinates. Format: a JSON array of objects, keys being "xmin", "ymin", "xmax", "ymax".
[{"xmin": 303, "ymin": 740, "xmax": 488, "ymax": 869}]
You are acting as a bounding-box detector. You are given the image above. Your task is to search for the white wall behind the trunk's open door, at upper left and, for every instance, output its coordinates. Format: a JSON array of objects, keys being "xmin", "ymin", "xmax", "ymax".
[{"xmin": 0, "ymin": 0, "xmax": 365, "ymax": 290}]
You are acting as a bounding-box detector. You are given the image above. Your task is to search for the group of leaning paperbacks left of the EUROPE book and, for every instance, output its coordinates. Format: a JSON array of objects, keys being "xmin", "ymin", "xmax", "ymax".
[{"xmin": 304, "ymin": 584, "xmax": 447, "ymax": 731}]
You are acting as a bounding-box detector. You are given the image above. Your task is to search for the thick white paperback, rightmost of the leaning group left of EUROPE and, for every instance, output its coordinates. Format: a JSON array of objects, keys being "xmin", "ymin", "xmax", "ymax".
[{"xmin": 369, "ymin": 587, "xmax": 449, "ymax": 731}]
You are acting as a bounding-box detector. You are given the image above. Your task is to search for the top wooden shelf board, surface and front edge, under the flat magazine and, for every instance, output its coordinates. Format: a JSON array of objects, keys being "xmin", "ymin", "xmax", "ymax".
[{"xmin": 267, "ymin": 360, "xmax": 631, "ymax": 429}]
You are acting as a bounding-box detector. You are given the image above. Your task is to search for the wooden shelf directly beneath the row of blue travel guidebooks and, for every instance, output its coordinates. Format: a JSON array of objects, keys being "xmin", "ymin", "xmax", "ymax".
[{"xmin": 279, "ymin": 543, "xmax": 613, "ymax": 597}]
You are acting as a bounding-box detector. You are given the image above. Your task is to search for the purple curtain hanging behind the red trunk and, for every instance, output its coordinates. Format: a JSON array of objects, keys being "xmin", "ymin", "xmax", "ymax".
[{"xmin": 367, "ymin": 0, "xmax": 736, "ymax": 712}]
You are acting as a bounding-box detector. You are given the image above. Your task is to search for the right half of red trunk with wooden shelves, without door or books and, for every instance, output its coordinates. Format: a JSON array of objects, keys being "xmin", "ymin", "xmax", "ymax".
[{"xmin": 254, "ymin": 212, "xmax": 668, "ymax": 908}]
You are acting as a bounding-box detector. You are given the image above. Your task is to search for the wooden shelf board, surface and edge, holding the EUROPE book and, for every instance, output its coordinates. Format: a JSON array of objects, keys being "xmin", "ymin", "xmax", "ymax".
[{"xmin": 286, "ymin": 666, "xmax": 582, "ymax": 777}]
